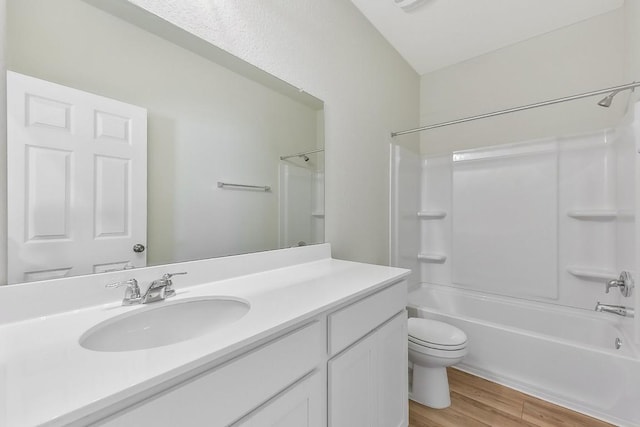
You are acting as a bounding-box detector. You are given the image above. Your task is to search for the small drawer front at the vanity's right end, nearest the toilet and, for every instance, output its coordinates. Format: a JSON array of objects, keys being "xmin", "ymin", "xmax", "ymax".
[{"xmin": 327, "ymin": 280, "xmax": 407, "ymax": 356}]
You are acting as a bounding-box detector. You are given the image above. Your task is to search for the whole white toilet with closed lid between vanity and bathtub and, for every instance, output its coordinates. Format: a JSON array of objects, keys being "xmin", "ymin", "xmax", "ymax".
[{"xmin": 408, "ymin": 317, "xmax": 467, "ymax": 409}]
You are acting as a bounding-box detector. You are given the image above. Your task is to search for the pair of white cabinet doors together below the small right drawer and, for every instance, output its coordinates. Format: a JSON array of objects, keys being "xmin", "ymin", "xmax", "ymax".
[{"xmin": 328, "ymin": 311, "xmax": 408, "ymax": 427}]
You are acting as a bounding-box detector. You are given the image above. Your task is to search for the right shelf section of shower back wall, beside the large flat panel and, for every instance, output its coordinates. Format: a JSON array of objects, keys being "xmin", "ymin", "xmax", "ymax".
[{"xmin": 558, "ymin": 131, "xmax": 621, "ymax": 309}]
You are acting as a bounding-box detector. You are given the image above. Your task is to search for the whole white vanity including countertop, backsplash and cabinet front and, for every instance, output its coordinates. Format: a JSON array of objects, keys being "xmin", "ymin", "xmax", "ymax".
[{"xmin": 0, "ymin": 243, "xmax": 410, "ymax": 427}]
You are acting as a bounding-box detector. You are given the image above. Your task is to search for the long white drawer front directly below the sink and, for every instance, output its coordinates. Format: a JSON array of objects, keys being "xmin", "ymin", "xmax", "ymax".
[{"xmin": 101, "ymin": 321, "xmax": 324, "ymax": 426}]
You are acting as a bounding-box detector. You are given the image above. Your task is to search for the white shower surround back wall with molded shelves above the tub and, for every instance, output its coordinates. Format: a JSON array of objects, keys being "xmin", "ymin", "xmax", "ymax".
[{"xmin": 410, "ymin": 128, "xmax": 636, "ymax": 310}]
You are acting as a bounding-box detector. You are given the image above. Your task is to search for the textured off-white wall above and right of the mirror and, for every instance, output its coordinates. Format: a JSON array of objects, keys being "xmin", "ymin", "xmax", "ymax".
[{"xmin": 127, "ymin": 0, "xmax": 419, "ymax": 264}]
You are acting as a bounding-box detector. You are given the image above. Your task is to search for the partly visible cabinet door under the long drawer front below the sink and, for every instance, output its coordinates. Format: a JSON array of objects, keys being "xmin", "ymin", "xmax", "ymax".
[{"xmin": 234, "ymin": 372, "xmax": 324, "ymax": 427}]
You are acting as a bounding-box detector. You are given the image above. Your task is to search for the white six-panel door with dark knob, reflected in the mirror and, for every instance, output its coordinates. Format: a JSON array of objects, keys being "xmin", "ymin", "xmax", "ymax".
[{"xmin": 7, "ymin": 71, "xmax": 147, "ymax": 283}]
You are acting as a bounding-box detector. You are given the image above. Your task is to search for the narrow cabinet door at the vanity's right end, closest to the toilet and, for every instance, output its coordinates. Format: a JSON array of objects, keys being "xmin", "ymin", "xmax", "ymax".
[{"xmin": 376, "ymin": 311, "xmax": 409, "ymax": 427}]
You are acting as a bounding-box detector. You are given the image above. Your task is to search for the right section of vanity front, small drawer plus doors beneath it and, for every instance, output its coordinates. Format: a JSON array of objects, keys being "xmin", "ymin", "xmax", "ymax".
[{"xmin": 328, "ymin": 282, "xmax": 408, "ymax": 427}]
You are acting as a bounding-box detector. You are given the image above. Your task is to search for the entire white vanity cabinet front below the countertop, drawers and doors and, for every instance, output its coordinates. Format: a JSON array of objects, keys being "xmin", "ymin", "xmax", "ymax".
[{"xmin": 97, "ymin": 281, "xmax": 408, "ymax": 427}]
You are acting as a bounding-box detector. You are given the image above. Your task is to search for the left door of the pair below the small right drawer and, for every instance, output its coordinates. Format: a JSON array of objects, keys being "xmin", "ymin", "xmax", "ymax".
[{"xmin": 328, "ymin": 334, "xmax": 376, "ymax": 427}]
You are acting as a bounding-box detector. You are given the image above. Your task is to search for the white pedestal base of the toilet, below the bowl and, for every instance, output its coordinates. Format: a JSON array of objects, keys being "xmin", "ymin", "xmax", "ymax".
[{"xmin": 411, "ymin": 363, "xmax": 451, "ymax": 409}]
